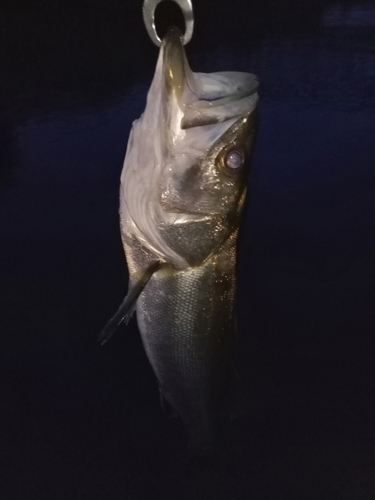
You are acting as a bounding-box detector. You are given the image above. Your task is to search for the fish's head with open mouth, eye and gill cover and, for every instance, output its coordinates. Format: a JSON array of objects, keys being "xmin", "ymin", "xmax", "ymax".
[{"xmin": 120, "ymin": 28, "xmax": 258, "ymax": 267}]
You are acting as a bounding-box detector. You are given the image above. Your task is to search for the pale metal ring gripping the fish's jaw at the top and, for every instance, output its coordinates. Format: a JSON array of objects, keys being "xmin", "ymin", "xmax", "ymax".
[{"xmin": 143, "ymin": 0, "xmax": 194, "ymax": 47}]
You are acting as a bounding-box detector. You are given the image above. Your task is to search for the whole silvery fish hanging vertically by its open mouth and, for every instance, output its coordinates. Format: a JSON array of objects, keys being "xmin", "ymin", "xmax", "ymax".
[{"xmin": 101, "ymin": 28, "xmax": 259, "ymax": 455}]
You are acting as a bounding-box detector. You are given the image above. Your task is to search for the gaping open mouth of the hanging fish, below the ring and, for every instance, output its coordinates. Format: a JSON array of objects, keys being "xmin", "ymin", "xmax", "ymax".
[{"xmin": 162, "ymin": 28, "xmax": 259, "ymax": 130}]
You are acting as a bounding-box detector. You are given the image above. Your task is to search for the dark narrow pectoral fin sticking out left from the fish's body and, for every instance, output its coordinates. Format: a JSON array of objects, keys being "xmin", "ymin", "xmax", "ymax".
[{"xmin": 99, "ymin": 260, "xmax": 162, "ymax": 345}]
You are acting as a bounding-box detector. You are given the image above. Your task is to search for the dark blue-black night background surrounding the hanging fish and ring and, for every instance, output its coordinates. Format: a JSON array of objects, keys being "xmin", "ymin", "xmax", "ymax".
[{"xmin": 0, "ymin": 0, "xmax": 375, "ymax": 500}]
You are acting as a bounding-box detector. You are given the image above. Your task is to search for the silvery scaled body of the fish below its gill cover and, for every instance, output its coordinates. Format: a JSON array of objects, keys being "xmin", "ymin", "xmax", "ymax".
[{"xmin": 137, "ymin": 235, "xmax": 235, "ymax": 450}]
